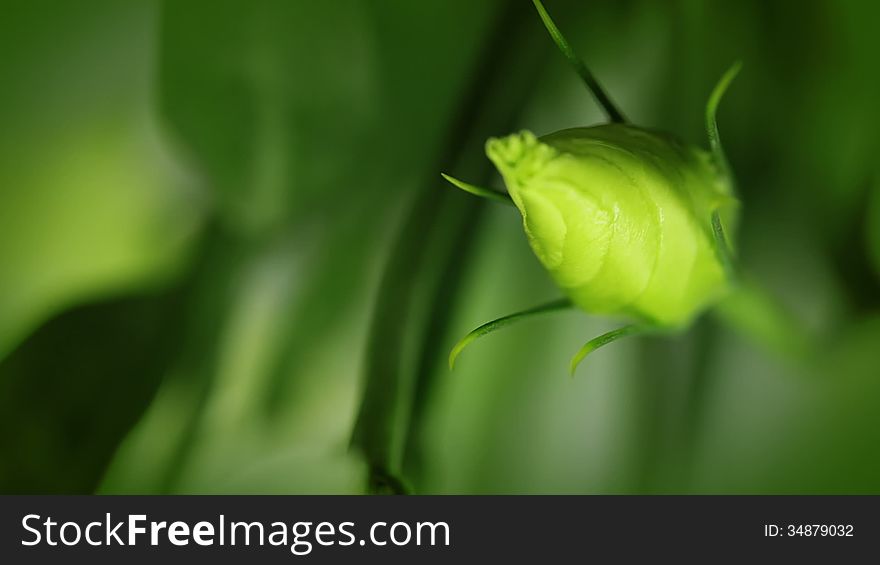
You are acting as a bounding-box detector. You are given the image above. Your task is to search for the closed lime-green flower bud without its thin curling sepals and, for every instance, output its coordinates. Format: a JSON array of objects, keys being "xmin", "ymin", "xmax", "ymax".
[{"xmin": 486, "ymin": 123, "xmax": 736, "ymax": 326}]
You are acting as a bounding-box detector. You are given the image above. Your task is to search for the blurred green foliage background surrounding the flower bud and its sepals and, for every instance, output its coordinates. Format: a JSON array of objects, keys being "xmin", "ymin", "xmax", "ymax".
[{"xmin": 0, "ymin": 0, "xmax": 880, "ymax": 493}]
